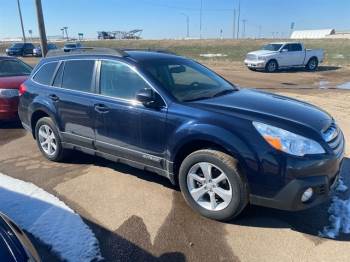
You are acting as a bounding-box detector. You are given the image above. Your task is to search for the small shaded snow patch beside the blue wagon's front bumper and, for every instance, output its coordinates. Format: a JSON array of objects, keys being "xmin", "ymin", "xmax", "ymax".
[{"xmin": 319, "ymin": 178, "xmax": 350, "ymax": 238}]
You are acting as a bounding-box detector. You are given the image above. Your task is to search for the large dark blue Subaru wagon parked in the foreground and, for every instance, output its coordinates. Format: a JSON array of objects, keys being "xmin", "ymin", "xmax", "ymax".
[{"xmin": 19, "ymin": 50, "xmax": 344, "ymax": 220}]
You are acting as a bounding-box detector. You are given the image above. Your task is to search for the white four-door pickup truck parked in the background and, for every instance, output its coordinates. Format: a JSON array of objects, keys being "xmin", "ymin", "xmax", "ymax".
[{"xmin": 244, "ymin": 42, "xmax": 324, "ymax": 72}]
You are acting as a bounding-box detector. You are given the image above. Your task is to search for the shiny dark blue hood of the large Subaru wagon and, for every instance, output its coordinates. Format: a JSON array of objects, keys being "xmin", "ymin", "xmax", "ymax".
[{"xmin": 193, "ymin": 89, "xmax": 333, "ymax": 132}]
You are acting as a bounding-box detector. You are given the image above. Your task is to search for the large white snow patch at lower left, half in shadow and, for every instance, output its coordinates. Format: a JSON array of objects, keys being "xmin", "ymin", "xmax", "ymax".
[{"xmin": 0, "ymin": 173, "xmax": 102, "ymax": 262}]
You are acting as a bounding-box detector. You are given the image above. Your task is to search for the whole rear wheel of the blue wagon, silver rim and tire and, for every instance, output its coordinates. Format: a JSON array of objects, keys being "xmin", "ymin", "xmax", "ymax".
[{"xmin": 35, "ymin": 117, "xmax": 67, "ymax": 161}]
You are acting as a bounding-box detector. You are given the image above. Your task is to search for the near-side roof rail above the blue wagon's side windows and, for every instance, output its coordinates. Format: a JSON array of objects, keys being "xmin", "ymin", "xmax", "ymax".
[{"xmin": 46, "ymin": 47, "xmax": 128, "ymax": 57}]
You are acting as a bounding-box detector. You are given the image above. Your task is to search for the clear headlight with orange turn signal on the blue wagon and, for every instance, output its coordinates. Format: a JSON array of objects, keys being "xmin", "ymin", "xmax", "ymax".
[{"xmin": 253, "ymin": 122, "xmax": 325, "ymax": 156}]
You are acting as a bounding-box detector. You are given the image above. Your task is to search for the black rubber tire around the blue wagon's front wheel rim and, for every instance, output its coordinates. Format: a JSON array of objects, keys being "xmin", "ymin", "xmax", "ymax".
[{"xmin": 179, "ymin": 149, "xmax": 249, "ymax": 221}]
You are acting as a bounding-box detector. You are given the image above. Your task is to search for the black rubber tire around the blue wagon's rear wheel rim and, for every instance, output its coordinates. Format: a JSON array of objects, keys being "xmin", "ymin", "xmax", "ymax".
[{"xmin": 35, "ymin": 117, "xmax": 68, "ymax": 162}]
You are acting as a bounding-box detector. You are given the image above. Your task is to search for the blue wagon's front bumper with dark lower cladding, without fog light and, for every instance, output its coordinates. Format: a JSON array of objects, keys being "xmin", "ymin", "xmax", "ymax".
[{"xmin": 250, "ymin": 143, "xmax": 345, "ymax": 211}]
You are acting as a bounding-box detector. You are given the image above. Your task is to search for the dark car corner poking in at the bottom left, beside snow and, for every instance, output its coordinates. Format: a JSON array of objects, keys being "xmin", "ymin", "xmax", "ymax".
[{"xmin": 0, "ymin": 213, "xmax": 40, "ymax": 262}]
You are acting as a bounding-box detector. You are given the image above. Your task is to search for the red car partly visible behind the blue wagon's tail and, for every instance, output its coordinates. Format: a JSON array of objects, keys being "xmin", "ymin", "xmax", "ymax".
[{"xmin": 0, "ymin": 56, "xmax": 32, "ymax": 120}]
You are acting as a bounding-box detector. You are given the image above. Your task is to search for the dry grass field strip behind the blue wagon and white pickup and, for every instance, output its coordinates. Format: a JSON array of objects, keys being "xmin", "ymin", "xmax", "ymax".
[{"xmin": 0, "ymin": 39, "xmax": 350, "ymax": 66}]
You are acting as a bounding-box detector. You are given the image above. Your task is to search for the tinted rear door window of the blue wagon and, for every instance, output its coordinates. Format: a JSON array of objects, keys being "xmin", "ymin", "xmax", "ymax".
[{"xmin": 62, "ymin": 60, "xmax": 95, "ymax": 93}]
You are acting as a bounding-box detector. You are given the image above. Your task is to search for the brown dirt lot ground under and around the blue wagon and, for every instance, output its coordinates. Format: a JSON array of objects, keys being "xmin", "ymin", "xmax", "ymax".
[{"xmin": 0, "ymin": 58, "xmax": 350, "ymax": 262}]
